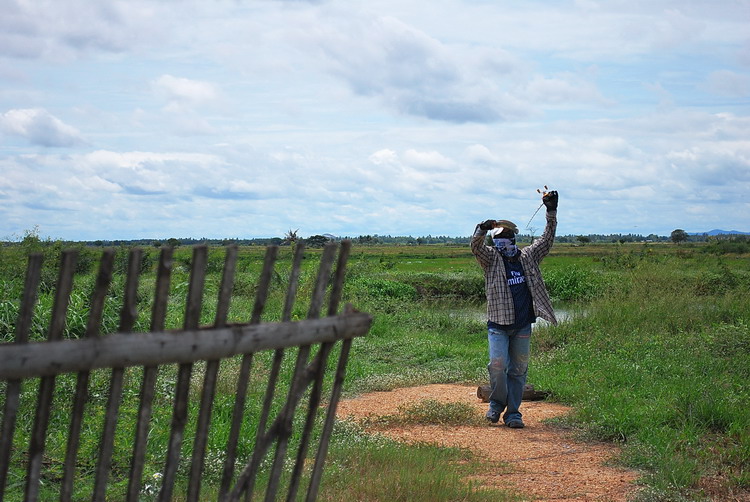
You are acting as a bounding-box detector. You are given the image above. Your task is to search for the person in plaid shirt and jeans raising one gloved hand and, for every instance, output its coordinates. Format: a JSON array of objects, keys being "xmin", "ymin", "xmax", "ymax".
[{"xmin": 471, "ymin": 191, "xmax": 558, "ymax": 429}]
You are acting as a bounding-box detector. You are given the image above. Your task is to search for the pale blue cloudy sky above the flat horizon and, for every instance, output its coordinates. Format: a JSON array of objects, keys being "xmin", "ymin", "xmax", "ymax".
[{"xmin": 0, "ymin": 0, "xmax": 750, "ymax": 240}]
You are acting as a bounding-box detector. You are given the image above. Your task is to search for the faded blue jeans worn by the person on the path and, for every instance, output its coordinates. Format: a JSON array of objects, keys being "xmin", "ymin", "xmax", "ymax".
[{"xmin": 487, "ymin": 324, "xmax": 531, "ymax": 423}]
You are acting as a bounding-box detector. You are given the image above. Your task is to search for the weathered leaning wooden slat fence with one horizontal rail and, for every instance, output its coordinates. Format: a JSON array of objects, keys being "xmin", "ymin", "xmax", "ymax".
[{"xmin": 0, "ymin": 241, "xmax": 372, "ymax": 502}]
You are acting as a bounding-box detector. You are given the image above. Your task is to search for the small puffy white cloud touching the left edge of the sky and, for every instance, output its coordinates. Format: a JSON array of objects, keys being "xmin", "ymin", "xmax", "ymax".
[{"xmin": 0, "ymin": 108, "xmax": 85, "ymax": 147}]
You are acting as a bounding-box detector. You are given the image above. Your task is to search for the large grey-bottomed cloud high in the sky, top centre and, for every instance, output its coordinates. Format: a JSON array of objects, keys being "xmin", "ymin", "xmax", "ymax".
[{"xmin": 301, "ymin": 12, "xmax": 523, "ymax": 123}]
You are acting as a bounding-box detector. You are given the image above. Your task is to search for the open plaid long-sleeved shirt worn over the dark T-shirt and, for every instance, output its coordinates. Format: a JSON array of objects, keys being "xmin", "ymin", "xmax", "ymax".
[{"xmin": 471, "ymin": 211, "xmax": 557, "ymax": 326}]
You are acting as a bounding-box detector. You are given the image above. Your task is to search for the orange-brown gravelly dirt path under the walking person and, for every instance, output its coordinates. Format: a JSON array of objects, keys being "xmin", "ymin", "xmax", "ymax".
[{"xmin": 338, "ymin": 384, "xmax": 638, "ymax": 501}]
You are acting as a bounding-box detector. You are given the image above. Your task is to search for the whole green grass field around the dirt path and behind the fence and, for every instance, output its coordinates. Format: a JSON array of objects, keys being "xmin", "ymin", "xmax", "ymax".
[{"xmin": 0, "ymin": 238, "xmax": 750, "ymax": 501}]
